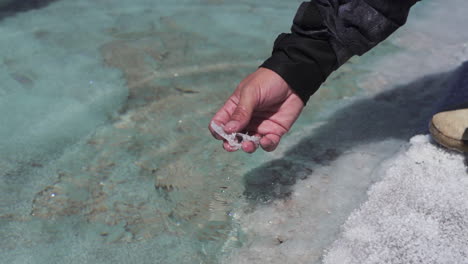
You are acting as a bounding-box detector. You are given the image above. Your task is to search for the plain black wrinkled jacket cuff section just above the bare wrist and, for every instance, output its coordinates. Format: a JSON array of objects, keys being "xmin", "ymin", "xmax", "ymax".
[{"xmin": 260, "ymin": 2, "xmax": 337, "ymax": 105}]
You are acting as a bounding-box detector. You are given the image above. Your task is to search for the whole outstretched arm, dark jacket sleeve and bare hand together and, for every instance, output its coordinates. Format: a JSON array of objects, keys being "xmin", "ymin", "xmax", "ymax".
[{"xmin": 210, "ymin": 0, "xmax": 418, "ymax": 152}]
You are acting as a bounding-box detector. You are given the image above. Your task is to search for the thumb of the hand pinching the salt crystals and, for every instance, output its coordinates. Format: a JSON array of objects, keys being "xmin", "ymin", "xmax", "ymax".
[{"xmin": 224, "ymin": 89, "xmax": 256, "ymax": 133}]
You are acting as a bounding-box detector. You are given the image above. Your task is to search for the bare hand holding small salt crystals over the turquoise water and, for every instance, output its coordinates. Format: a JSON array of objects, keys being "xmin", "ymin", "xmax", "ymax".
[{"xmin": 210, "ymin": 68, "xmax": 304, "ymax": 153}]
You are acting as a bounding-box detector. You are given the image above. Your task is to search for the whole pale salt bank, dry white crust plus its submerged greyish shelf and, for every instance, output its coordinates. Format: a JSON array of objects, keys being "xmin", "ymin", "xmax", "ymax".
[{"xmin": 222, "ymin": 136, "xmax": 468, "ymax": 264}]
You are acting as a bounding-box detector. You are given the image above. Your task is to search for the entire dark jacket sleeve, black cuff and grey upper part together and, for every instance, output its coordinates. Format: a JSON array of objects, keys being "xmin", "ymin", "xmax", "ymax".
[{"xmin": 261, "ymin": 0, "xmax": 419, "ymax": 104}]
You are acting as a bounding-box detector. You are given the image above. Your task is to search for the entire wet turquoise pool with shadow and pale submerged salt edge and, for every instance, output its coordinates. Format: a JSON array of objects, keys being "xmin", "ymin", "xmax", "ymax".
[{"xmin": 0, "ymin": 0, "xmax": 467, "ymax": 263}]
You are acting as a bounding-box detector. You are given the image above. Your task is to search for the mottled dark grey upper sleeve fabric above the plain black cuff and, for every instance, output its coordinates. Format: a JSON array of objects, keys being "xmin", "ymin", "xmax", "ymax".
[{"xmin": 315, "ymin": 0, "xmax": 419, "ymax": 65}]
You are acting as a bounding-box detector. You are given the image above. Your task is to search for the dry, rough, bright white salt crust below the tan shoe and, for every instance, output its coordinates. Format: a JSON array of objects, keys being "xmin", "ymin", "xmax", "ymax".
[{"xmin": 324, "ymin": 136, "xmax": 468, "ymax": 264}]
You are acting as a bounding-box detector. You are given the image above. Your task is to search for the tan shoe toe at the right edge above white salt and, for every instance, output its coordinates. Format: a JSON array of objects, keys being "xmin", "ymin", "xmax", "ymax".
[{"xmin": 429, "ymin": 108, "xmax": 468, "ymax": 152}]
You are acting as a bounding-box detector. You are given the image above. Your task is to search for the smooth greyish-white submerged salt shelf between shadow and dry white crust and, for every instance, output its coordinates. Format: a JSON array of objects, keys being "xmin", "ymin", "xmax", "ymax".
[{"xmin": 222, "ymin": 139, "xmax": 407, "ymax": 264}]
